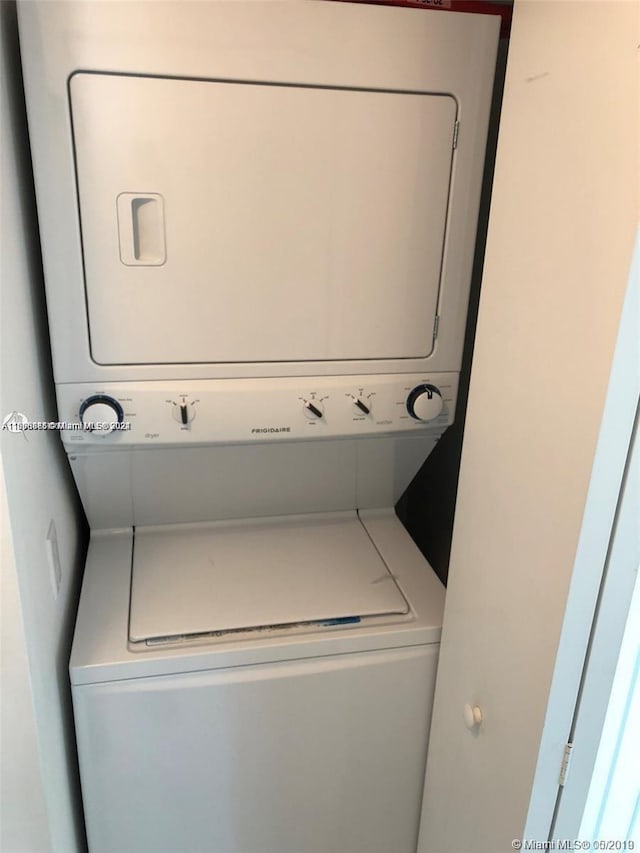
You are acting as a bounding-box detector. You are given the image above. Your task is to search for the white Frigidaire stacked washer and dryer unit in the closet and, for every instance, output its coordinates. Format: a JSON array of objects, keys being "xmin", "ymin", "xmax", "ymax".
[{"xmin": 19, "ymin": 2, "xmax": 498, "ymax": 853}]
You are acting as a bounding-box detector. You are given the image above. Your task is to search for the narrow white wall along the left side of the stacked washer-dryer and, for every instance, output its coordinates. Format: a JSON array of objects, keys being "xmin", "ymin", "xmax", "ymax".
[{"xmin": 0, "ymin": 2, "xmax": 84, "ymax": 853}]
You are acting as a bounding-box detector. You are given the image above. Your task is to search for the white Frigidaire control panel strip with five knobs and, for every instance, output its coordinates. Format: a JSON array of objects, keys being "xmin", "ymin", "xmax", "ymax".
[{"xmin": 57, "ymin": 373, "xmax": 458, "ymax": 448}]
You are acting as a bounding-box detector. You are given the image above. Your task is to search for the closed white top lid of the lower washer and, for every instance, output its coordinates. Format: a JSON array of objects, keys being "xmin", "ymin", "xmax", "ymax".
[{"xmin": 129, "ymin": 512, "xmax": 409, "ymax": 642}]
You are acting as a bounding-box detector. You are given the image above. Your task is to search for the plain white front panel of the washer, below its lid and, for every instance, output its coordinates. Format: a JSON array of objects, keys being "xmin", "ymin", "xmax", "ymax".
[{"xmin": 74, "ymin": 645, "xmax": 438, "ymax": 853}]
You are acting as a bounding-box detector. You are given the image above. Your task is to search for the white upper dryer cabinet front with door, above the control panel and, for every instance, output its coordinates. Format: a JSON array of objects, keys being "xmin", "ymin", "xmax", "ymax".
[{"xmin": 20, "ymin": 0, "xmax": 499, "ymax": 383}]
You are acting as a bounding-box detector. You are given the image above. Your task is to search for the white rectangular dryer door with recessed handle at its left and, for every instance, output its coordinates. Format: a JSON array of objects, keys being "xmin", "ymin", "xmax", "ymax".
[{"xmin": 70, "ymin": 73, "xmax": 457, "ymax": 364}]
